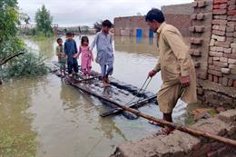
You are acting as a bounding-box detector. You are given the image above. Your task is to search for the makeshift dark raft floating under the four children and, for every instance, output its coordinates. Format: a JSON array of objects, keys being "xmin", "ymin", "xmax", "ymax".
[{"xmin": 52, "ymin": 63, "xmax": 156, "ymax": 117}]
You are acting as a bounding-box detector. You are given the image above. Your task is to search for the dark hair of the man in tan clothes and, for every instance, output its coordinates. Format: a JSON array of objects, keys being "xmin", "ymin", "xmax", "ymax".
[{"xmin": 145, "ymin": 9, "xmax": 165, "ymax": 23}]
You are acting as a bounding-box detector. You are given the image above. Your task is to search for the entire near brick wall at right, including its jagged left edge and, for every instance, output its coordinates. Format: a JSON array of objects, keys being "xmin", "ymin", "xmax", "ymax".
[{"xmin": 189, "ymin": 0, "xmax": 236, "ymax": 108}]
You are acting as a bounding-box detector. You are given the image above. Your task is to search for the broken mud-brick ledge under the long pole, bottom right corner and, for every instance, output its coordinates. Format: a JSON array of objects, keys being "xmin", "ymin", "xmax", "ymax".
[{"xmin": 110, "ymin": 110, "xmax": 236, "ymax": 157}]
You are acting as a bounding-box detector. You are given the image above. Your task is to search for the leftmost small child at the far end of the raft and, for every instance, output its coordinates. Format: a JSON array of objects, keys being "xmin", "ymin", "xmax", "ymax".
[{"xmin": 56, "ymin": 38, "xmax": 66, "ymax": 77}]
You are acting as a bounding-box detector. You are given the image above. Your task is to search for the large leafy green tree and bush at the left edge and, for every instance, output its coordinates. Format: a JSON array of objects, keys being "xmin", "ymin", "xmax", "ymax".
[{"xmin": 0, "ymin": 0, "xmax": 46, "ymax": 79}]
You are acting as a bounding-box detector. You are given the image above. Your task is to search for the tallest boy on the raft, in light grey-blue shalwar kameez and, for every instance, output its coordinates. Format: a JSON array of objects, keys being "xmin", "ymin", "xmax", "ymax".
[{"xmin": 91, "ymin": 20, "xmax": 114, "ymax": 87}]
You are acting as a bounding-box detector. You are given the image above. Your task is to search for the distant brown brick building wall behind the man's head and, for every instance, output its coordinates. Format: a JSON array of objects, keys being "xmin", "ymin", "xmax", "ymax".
[{"xmin": 114, "ymin": 3, "xmax": 193, "ymax": 37}]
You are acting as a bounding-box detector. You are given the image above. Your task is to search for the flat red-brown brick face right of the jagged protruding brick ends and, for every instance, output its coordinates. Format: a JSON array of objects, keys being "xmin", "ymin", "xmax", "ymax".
[{"xmin": 208, "ymin": 0, "xmax": 236, "ymax": 88}]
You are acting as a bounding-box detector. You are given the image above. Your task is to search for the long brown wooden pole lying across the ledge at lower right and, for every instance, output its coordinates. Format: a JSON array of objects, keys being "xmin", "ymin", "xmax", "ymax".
[{"xmin": 111, "ymin": 104, "xmax": 236, "ymax": 148}]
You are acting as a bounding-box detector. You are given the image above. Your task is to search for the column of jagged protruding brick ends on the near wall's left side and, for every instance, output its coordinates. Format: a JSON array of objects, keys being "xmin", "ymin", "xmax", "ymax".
[{"xmin": 189, "ymin": 0, "xmax": 213, "ymax": 103}]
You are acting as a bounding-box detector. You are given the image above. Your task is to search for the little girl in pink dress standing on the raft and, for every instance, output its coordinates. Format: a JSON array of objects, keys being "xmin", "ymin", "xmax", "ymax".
[{"xmin": 76, "ymin": 36, "xmax": 93, "ymax": 77}]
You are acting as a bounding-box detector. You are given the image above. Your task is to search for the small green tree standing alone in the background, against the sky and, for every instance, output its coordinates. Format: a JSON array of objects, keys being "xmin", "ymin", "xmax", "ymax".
[{"xmin": 35, "ymin": 5, "xmax": 53, "ymax": 36}]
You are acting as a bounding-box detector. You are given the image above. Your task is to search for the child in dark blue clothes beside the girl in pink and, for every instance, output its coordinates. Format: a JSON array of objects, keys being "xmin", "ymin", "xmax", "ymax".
[{"xmin": 64, "ymin": 32, "xmax": 78, "ymax": 77}]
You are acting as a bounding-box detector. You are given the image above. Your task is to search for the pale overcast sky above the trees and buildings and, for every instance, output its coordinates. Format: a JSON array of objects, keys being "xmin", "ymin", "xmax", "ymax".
[{"xmin": 18, "ymin": 0, "xmax": 193, "ymax": 26}]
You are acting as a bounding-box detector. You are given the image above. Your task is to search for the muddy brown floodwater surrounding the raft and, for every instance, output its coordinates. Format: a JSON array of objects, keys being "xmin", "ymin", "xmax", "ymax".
[{"xmin": 0, "ymin": 36, "xmax": 186, "ymax": 157}]
